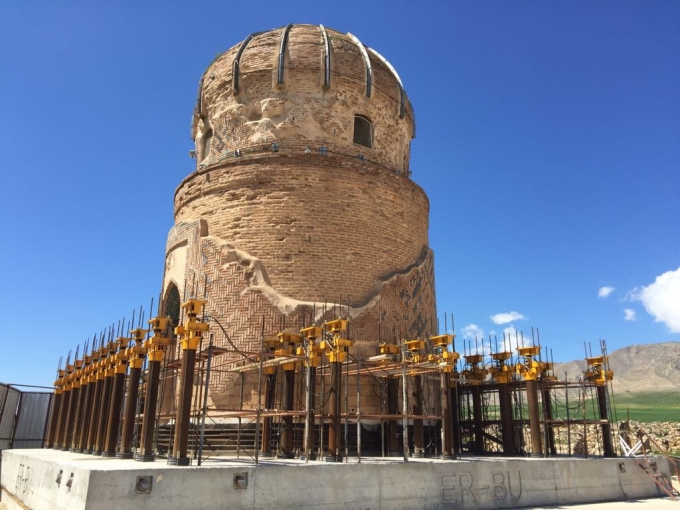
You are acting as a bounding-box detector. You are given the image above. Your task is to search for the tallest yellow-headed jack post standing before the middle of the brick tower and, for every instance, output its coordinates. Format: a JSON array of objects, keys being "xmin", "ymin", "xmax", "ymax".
[{"xmin": 319, "ymin": 319, "xmax": 354, "ymax": 462}]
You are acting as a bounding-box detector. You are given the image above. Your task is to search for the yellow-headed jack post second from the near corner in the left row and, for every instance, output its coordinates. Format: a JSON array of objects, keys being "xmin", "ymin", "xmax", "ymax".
[{"xmin": 130, "ymin": 317, "xmax": 169, "ymax": 462}]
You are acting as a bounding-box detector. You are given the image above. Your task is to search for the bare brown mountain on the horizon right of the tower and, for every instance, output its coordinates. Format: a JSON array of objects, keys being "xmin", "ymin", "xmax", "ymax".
[{"xmin": 555, "ymin": 342, "xmax": 680, "ymax": 394}]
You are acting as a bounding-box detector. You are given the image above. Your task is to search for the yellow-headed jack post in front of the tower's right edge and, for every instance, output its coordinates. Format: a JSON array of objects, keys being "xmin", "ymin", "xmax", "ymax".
[{"xmin": 428, "ymin": 335, "xmax": 460, "ymax": 460}]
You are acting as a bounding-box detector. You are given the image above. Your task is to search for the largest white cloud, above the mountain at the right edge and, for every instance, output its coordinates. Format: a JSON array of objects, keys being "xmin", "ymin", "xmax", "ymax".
[{"xmin": 631, "ymin": 267, "xmax": 680, "ymax": 333}]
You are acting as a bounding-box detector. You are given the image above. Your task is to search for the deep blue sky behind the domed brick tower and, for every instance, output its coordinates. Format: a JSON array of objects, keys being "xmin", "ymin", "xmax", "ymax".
[{"xmin": 0, "ymin": 0, "xmax": 680, "ymax": 384}]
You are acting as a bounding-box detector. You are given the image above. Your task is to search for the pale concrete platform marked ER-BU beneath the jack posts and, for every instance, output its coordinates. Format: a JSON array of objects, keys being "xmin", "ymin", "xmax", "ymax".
[{"xmin": 1, "ymin": 450, "xmax": 669, "ymax": 510}]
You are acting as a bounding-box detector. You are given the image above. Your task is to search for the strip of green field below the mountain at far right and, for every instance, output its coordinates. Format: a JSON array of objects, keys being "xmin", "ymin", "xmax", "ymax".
[{"xmin": 612, "ymin": 391, "xmax": 680, "ymax": 423}]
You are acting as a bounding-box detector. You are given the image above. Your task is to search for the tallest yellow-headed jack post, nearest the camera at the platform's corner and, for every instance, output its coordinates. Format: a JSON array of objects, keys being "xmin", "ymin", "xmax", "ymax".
[{"xmin": 168, "ymin": 299, "xmax": 210, "ymax": 466}]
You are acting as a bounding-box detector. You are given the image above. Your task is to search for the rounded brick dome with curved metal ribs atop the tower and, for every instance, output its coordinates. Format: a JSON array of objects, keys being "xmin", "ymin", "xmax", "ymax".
[{"xmin": 192, "ymin": 24, "xmax": 415, "ymax": 176}]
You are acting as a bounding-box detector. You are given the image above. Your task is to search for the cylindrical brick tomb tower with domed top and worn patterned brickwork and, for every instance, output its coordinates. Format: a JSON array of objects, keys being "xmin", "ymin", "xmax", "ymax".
[{"xmin": 163, "ymin": 25, "xmax": 436, "ymax": 410}]
